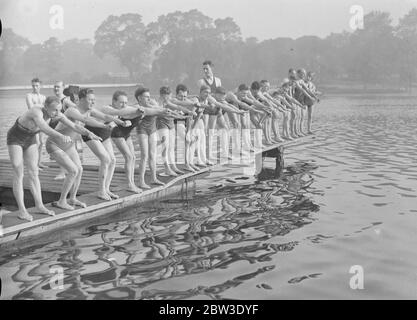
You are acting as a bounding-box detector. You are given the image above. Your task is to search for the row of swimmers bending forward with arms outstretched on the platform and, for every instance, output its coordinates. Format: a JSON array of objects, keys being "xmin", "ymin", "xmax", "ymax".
[{"xmin": 7, "ymin": 69, "xmax": 319, "ymax": 221}]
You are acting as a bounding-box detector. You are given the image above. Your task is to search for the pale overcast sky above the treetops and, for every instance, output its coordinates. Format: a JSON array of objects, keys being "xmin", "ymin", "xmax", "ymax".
[{"xmin": 0, "ymin": 0, "xmax": 417, "ymax": 43}]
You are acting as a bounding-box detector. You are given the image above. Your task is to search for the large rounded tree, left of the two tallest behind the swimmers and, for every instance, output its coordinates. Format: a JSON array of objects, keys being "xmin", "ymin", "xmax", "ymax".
[{"xmin": 94, "ymin": 13, "xmax": 150, "ymax": 81}]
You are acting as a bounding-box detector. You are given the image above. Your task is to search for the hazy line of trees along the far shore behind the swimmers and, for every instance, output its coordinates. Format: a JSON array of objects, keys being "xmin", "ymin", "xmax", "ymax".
[{"xmin": 0, "ymin": 8, "xmax": 417, "ymax": 90}]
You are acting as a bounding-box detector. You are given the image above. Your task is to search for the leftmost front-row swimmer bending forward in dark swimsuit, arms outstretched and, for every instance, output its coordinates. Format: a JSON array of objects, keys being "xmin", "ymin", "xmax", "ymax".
[{"xmin": 7, "ymin": 97, "xmax": 71, "ymax": 221}]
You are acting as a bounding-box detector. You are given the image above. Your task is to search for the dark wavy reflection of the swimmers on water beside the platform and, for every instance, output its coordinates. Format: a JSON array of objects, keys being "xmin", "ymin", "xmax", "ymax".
[{"xmin": 1, "ymin": 160, "xmax": 319, "ymax": 299}]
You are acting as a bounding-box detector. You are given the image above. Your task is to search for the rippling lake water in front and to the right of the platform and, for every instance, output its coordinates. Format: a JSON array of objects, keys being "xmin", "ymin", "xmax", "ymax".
[{"xmin": 0, "ymin": 90, "xmax": 417, "ymax": 299}]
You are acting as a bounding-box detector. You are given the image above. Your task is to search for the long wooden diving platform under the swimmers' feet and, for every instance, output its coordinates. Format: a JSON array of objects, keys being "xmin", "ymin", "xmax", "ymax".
[{"xmin": 0, "ymin": 136, "xmax": 312, "ymax": 249}]
